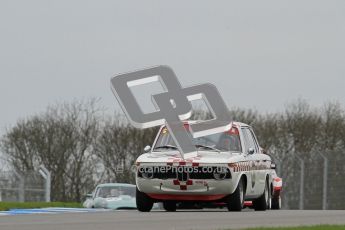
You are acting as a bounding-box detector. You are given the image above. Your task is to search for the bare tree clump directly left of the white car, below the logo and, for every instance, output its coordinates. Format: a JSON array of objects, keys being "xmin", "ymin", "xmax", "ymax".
[{"xmin": 94, "ymin": 114, "xmax": 158, "ymax": 183}]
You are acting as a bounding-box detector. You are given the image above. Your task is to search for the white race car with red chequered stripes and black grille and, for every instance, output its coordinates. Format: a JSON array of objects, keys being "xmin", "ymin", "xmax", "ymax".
[{"xmin": 136, "ymin": 121, "xmax": 281, "ymax": 212}]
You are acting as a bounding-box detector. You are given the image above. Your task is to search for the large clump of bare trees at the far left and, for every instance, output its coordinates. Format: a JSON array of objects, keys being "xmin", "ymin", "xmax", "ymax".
[{"xmin": 1, "ymin": 99, "xmax": 102, "ymax": 201}]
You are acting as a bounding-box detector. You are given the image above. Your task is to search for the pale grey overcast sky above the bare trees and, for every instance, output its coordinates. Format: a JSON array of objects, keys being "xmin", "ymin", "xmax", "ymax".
[{"xmin": 0, "ymin": 0, "xmax": 345, "ymax": 132}]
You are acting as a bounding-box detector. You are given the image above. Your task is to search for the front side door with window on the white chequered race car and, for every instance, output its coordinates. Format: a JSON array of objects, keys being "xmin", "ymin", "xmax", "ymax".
[{"xmin": 242, "ymin": 127, "xmax": 262, "ymax": 196}]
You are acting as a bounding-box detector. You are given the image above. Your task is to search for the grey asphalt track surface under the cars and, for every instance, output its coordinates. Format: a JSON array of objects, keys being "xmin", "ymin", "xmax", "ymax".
[{"xmin": 0, "ymin": 210, "xmax": 345, "ymax": 230}]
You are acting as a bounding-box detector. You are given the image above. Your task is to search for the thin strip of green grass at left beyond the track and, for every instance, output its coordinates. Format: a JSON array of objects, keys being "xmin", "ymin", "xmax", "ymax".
[{"xmin": 0, "ymin": 202, "xmax": 82, "ymax": 211}]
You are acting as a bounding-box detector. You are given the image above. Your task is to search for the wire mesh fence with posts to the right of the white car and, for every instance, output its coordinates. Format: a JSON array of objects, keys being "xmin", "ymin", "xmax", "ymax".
[{"xmin": 273, "ymin": 151, "xmax": 345, "ymax": 209}]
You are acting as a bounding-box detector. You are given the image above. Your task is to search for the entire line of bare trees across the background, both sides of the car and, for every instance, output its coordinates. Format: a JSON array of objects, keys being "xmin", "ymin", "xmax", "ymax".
[{"xmin": 0, "ymin": 98, "xmax": 345, "ymax": 201}]
